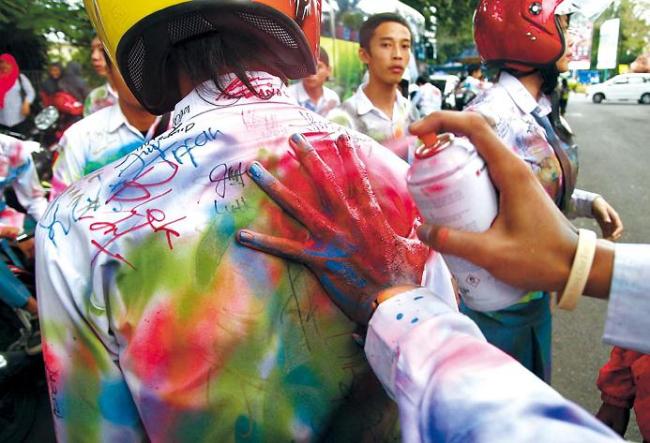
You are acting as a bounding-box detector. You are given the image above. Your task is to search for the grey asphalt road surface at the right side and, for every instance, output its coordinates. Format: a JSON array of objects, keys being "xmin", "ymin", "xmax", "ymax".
[{"xmin": 553, "ymin": 96, "xmax": 650, "ymax": 441}]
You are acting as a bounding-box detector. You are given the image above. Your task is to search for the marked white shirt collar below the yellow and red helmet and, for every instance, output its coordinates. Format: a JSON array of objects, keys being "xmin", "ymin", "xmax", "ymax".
[{"xmin": 172, "ymin": 71, "xmax": 295, "ymax": 126}]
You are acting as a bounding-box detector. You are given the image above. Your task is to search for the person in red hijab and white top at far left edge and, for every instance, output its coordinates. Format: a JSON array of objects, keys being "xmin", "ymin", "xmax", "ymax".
[{"xmin": 0, "ymin": 53, "xmax": 35, "ymax": 134}]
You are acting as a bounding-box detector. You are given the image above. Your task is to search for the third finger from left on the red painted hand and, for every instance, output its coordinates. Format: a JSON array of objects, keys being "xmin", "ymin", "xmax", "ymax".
[{"xmin": 289, "ymin": 134, "xmax": 347, "ymax": 209}]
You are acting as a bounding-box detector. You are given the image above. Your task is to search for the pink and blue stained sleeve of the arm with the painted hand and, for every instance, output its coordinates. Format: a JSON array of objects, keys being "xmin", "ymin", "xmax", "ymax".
[{"xmin": 366, "ymin": 288, "xmax": 622, "ymax": 442}]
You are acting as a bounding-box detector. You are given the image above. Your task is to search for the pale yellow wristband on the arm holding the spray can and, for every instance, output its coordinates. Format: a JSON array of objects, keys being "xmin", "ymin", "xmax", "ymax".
[{"xmin": 557, "ymin": 229, "xmax": 596, "ymax": 311}]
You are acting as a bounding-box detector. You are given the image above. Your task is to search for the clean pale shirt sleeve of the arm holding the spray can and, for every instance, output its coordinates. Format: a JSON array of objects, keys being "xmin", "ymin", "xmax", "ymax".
[{"xmin": 603, "ymin": 244, "xmax": 650, "ymax": 354}]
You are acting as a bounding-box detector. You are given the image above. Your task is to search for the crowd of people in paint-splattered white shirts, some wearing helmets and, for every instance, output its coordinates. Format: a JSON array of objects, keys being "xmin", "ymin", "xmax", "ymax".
[{"xmin": 0, "ymin": 0, "xmax": 650, "ymax": 442}]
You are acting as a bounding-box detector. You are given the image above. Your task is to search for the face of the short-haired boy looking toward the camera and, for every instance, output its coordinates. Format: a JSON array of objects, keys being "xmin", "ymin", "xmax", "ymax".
[{"xmin": 359, "ymin": 22, "xmax": 411, "ymax": 85}]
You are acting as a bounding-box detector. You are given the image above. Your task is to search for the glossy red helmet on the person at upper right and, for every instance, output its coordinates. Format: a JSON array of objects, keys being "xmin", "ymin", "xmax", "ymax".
[{"xmin": 474, "ymin": 0, "xmax": 566, "ymax": 72}]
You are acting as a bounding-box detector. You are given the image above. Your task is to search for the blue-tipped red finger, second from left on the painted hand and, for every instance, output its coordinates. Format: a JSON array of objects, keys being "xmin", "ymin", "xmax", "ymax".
[{"xmin": 248, "ymin": 162, "xmax": 335, "ymax": 236}]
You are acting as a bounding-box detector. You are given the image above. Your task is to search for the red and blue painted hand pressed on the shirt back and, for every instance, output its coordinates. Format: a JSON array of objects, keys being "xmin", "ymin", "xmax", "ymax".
[{"xmin": 237, "ymin": 135, "xmax": 429, "ymax": 324}]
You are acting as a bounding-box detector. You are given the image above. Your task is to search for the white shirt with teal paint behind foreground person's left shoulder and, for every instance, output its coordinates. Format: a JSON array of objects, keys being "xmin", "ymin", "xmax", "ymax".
[{"xmin": 51, "ymin": 104, "xmax": 166, "ymax": 198}]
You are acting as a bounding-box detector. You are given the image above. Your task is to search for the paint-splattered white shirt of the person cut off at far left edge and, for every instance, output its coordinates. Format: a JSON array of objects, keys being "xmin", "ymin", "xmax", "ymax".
[{"xmin": 0, "ymin": 134, "xmax": 47, "ymax": 229}]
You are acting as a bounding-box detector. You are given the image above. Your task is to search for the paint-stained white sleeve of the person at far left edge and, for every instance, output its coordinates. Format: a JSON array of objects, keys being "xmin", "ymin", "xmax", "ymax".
[{"xmin": 12, "ymin": 142, "xmax": 47, "ymax": 221}]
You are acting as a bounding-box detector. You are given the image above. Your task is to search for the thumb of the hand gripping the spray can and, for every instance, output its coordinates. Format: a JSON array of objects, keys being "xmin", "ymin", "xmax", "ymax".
[{"xmin": 417, "ymin": 224, "xmax": 489, "ymax": 267}]
